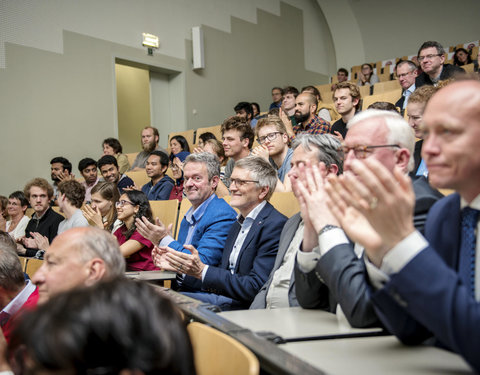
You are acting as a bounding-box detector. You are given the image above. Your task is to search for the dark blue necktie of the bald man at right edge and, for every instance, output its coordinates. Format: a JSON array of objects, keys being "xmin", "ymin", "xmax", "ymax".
[{"xmin": 458, "ymin": 207, "xmax": 480, "ymax": 298}]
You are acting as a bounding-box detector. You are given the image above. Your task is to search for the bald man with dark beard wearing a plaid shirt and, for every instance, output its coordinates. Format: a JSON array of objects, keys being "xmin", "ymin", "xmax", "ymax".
[{"xmin": 286, "ymin": 92, "xmax": 330, "ymax": 138}]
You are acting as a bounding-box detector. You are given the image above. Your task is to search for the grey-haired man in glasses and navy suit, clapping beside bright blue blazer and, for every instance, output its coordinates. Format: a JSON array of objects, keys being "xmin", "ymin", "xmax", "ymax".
[{"xmin": 154, "ymin": 156, "xmax": 287, "ymax": 310}]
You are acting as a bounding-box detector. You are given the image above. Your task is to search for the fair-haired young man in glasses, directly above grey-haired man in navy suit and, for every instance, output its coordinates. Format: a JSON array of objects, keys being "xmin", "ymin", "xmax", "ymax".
[{"xmin": 252, "ymin": 115, "xmax": 293, "ymax": 191}]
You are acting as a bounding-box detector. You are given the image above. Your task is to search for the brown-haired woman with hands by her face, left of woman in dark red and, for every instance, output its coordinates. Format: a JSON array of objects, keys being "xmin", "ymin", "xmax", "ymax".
[{"xmin": 82, "ymin": 182, "xmax": 122, "ymax": 233}]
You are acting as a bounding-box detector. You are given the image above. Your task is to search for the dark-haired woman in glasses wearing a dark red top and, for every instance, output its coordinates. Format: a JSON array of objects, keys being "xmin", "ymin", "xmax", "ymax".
[{"xmin": 113, "ymin": 190, "xmax": 157, "ymax": 271}]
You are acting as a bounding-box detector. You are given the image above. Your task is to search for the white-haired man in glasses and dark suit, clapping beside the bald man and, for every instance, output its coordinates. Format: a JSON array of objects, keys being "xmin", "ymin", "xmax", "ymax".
[{"xmin": 295, "ymin": 110, "xmax": 441, "ymax": 327}]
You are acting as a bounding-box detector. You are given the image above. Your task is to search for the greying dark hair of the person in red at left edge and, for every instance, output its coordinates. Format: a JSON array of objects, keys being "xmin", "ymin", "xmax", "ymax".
[{"xmin": 0, "ymin": 231, "xmax": 25, "ymax": 292}]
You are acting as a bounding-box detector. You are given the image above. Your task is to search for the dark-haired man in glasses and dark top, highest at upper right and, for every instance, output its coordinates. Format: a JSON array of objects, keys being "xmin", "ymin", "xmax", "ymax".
[{"xmin": 415, "ymin": 41, "xmax": 465, "ymax": 87}]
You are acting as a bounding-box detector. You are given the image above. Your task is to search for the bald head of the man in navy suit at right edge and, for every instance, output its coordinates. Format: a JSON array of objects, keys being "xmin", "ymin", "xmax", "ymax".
[{"xmin": 422, "ymin": 80, "xmax": 480, "ymax": 202}]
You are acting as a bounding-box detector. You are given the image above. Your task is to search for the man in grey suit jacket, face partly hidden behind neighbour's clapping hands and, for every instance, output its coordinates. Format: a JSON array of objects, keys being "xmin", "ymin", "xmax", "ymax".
[{"xmin": 250, "ymin": 134, "xmax": 343, "ymax": 309}]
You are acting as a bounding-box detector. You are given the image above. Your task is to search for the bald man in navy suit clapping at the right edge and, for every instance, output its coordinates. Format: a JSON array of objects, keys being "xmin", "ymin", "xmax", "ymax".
[{"xmin": 322, "ymin": 80, "xmax": 480, "ymax": 371}]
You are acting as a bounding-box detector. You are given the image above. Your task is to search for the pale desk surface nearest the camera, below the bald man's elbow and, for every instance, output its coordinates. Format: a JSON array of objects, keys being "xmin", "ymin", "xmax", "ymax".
[{"xmin": 278, "ymin": 336, "xmax": 473, "ymax": 375}]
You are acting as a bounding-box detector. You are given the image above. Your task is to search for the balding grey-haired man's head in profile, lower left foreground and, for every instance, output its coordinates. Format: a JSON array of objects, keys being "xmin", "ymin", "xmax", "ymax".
[{"xmin": 32, "ymin": 227, "xmax": 125, "ymax": 302}]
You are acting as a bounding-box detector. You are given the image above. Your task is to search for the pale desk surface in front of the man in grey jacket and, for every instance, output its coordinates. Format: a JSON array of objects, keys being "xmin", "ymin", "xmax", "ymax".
[{"xmin": 219, "ymin": 307, "xmax": 382, "ymax": 340}]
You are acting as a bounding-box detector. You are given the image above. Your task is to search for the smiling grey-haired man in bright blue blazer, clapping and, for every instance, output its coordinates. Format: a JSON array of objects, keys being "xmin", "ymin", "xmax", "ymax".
[{"xmin": 136, "ymin": 152, "xmax": 236, "ymax": 266}]
